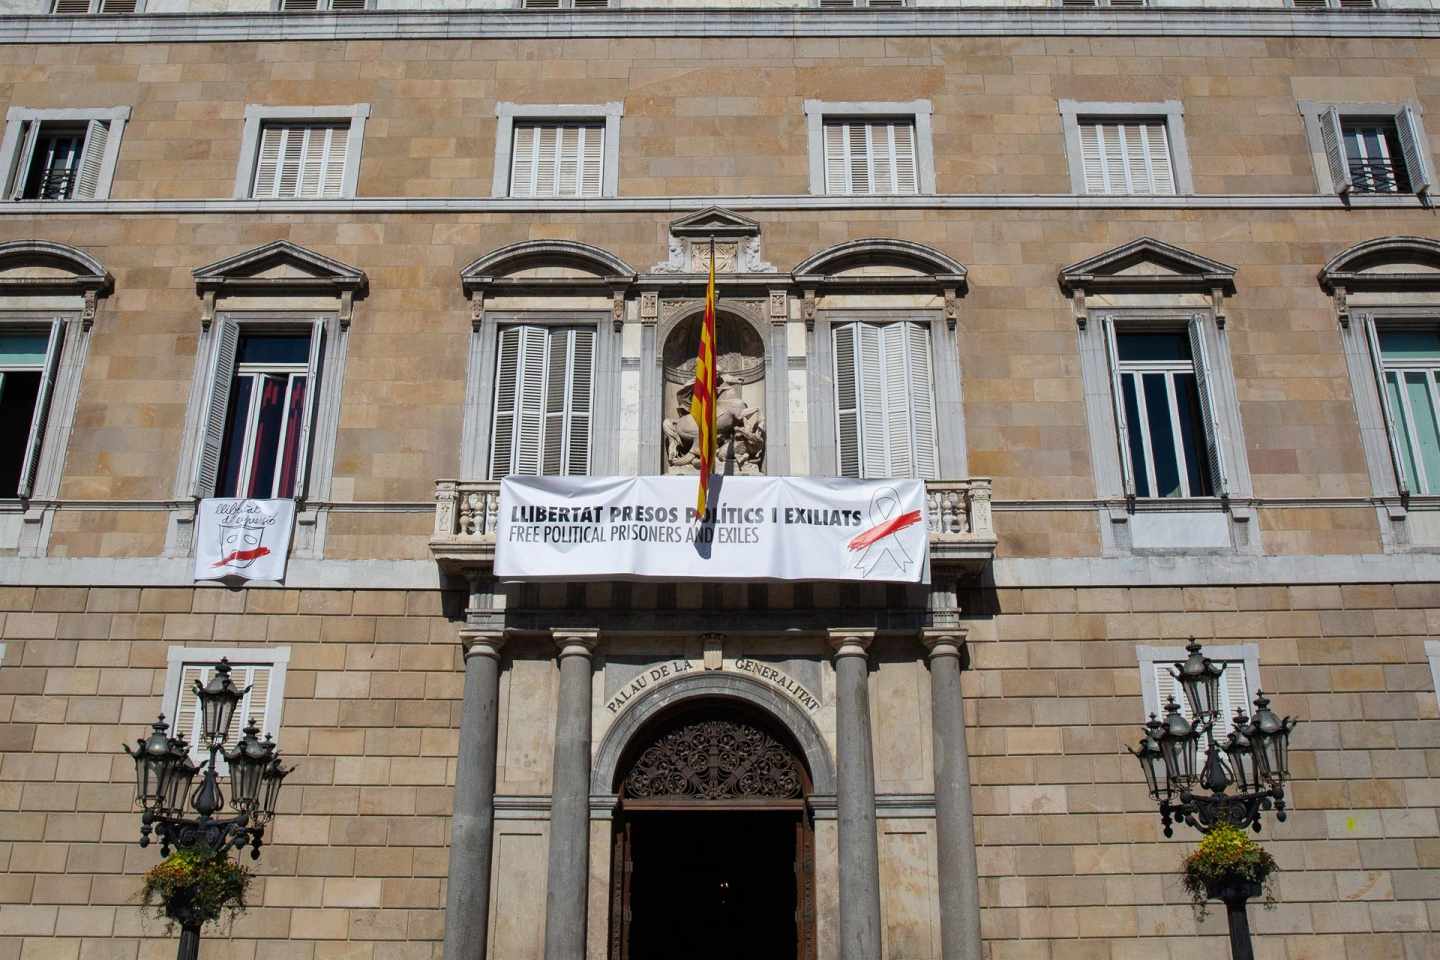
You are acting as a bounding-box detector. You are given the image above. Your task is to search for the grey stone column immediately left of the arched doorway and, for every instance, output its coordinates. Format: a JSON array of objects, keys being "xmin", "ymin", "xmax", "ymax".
[{"xmin": 544, "ymin": 629, "xmax": 599, "ymax": 960}]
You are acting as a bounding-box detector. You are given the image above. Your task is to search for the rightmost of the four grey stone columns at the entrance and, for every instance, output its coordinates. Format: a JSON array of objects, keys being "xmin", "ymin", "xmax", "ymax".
[{"xmin": 922, "ymin": 628, "xmax": 981, "ymax": 960}]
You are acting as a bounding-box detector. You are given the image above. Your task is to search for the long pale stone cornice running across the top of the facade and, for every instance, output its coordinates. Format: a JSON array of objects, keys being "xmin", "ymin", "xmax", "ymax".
[{"xmin": 0, "ymin": 7, "xmax": 1440, "ymax": 43}]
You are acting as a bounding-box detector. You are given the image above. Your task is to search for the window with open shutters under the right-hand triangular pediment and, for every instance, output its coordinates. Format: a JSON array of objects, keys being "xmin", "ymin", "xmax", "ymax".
[{"xmin": 1103, "ymin": 317, "xmax": 1224, "ymax": 498}]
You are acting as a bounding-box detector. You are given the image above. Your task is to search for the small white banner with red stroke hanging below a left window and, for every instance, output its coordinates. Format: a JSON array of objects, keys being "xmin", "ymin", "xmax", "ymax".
[{"xmin": 194, "ymin": 499, "xmax": 295, "ymax": 580}]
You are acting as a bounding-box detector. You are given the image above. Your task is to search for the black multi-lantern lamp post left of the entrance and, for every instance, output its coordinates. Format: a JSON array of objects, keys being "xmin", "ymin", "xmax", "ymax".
[{"xmin": 125, "ymin": 659, "xmax": 291, "ymax": 960}]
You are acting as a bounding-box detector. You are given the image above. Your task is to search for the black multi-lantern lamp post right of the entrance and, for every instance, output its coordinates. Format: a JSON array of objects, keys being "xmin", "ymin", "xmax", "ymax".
[{"xmin": 1130, "ymin": 638, "xmax": 1297, "ymax": 960}]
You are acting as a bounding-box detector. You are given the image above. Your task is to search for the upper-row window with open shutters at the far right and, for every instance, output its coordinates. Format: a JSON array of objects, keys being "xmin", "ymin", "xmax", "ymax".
[{"xmin": 1300, "ymin": 101, "xmax": 1434, "ymax": 197}]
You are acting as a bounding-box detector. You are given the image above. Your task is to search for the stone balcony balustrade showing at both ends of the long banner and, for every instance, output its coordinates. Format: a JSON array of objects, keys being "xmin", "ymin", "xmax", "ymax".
[{"xmin": 431, "ymin": 476, "xmax": 995, "ymax": 569}]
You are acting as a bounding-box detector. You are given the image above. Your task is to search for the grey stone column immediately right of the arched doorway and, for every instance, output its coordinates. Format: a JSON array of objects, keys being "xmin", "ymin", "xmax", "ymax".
[{"xmin": 829, "ymin": 629, "xmax": 880, "ymax": 960}]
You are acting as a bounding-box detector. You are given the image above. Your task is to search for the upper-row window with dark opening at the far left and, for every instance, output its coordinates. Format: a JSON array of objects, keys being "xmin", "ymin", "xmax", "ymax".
[{"xmin": 0, "ymin": 107, "xmax": 130, "ymax": 200}]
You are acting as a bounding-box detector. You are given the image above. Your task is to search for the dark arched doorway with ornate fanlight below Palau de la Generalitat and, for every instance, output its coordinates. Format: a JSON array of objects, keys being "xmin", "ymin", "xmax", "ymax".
[{"xmin": 609, "ymin": 698, "xmax": 815, "ymax": 960}]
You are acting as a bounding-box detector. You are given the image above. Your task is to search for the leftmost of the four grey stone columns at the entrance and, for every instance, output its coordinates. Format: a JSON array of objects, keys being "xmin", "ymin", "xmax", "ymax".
[{"xmin": 445, "ymin": 629, "xmax": 505, "ymax": 960}]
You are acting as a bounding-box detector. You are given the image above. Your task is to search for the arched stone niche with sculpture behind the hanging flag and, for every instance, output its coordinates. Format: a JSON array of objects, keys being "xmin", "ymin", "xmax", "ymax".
[{"xmin": 661, "ymin": 308, "xmax": 766, "ymax": 475}]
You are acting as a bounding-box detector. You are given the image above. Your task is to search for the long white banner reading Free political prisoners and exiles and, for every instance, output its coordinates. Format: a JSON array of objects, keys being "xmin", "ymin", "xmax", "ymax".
[{"xmin": 495, "ymin": 475, "xmax": 930, "ymax": 583}]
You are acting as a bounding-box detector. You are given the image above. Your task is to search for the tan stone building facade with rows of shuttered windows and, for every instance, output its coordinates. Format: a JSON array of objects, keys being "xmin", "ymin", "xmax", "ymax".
[{"xmin": 0, "ymin": 0, "xmax": 1440, "ymax": 960}]
